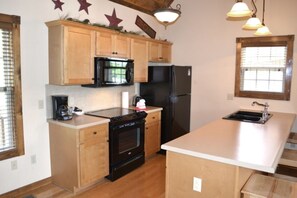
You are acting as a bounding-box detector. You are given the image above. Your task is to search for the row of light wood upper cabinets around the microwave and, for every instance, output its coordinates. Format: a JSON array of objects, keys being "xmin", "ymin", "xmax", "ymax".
[{"xmin": 46, "ymin": 20, "xmax": 172, "ymax": 85}]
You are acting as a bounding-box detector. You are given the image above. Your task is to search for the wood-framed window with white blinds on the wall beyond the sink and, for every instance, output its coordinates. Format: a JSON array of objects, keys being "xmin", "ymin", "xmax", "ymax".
[{"xmin": 235, "ymin": 35, "xmax": 294, "ymax": 100}]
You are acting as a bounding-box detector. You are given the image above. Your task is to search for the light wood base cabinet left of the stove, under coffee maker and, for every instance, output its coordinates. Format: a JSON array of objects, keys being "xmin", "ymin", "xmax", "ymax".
[{"xmin": 49, "ymin": 122, "xmax": 109, "ymax": 192}]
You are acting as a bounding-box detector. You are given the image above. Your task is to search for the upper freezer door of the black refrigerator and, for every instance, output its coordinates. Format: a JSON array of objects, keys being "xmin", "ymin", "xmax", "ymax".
[{"xmin": 172, "ymin": 66, "xmax": 192, "ymax": 95}]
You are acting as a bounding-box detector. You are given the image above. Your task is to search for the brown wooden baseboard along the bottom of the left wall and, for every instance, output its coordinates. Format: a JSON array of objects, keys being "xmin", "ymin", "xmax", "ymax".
[{"xmin": 0, "ymin": 177, "xmax": 52, "ymax": 198}]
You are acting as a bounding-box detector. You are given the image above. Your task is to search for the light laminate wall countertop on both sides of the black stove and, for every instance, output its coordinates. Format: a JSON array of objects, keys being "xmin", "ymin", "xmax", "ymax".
[{"xmin": 48, "ymin": 106, "xmax": 162, "ymax": 129}]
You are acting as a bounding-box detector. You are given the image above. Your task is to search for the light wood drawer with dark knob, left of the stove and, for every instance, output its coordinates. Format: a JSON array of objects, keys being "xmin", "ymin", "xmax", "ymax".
[{"xmin": 79, "ymin": 124, "xmax": 108, "ymax": 144}]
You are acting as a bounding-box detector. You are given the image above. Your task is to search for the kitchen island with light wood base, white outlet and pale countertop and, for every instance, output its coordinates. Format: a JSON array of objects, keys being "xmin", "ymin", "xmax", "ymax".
[{"xmin": 161, "ymin": 112, "xmax": 295, "ymax": 198}]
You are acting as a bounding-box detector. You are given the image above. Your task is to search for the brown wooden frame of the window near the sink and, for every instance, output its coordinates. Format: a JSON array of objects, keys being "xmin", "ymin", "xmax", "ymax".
[{"xmin": 234, "ymin": 35, "xmax": 294, "ymax": 100}]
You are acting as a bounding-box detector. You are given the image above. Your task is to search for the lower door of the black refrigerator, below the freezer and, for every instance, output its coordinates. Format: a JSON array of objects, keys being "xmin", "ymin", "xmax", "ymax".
[{"xmin": 171, "ymin": 94, "xmax": 191, "ymax": 139}]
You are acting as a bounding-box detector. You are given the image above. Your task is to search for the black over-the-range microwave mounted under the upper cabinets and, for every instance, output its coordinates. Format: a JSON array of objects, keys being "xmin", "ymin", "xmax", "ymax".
[{"xmin": 82, "ymin": 57, "xmax": 134, "ymax": 87}]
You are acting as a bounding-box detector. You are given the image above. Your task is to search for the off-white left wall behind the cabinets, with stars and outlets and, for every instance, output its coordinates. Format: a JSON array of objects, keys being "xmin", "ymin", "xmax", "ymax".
[{"xmin": 0, "ymin": 0, "xmax": 164, "ymax": 194}]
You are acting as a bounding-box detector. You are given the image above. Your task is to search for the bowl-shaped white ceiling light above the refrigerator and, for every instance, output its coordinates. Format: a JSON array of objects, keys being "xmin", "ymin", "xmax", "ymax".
[{"xmin": 154, "ymin": 4, "xmax": 181, "ymax": 27}]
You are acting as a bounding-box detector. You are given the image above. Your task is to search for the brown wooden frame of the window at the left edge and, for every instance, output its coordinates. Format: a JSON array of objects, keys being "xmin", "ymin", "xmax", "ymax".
[{"xmin": 0, "ymin": 13, "xmax": 25, "ymax": 160}]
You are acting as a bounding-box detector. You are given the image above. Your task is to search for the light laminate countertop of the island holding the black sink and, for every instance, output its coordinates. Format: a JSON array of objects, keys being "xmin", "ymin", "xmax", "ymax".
[{"xmin": 161, "ymin": 112, "xmax": 295, "ymax": 173}]
